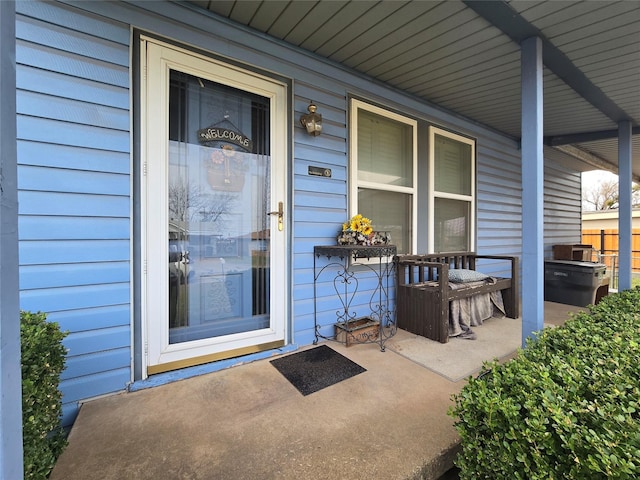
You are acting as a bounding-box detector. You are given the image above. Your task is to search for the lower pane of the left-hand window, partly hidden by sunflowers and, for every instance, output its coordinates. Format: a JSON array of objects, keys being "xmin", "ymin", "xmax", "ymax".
[{"xmin": 358, "ymin": 188, "xmax": 413, "ymax": 253}]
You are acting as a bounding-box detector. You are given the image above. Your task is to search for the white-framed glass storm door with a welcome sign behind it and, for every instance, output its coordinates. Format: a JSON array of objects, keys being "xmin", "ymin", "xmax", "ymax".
[{"xmin": 141, "ymin": 39, "xmax": 288, "ymax": 374}]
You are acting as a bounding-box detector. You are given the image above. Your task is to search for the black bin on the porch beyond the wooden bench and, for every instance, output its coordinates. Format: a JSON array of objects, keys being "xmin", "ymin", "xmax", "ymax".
[{"xmin": 544, "ymin": 260, "xmax": 606, "ymax": 307}]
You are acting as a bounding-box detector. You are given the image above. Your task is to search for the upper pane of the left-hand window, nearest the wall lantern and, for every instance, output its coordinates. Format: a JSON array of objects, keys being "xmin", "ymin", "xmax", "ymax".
[{"xmin": 358, "ymin": 109, "xmax": 413, "ymax": 187}]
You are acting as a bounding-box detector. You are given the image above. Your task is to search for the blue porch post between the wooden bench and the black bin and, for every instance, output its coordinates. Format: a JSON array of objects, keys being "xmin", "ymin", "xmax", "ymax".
[{"xmin": 520, "ymin": 37, "xmax": 544, "ymax": 347}]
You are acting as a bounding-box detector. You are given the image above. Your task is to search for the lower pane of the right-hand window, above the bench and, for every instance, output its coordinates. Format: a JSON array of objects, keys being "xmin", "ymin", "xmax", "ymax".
[{"xmin": 434, "ymin": 198, "xmax": 471, "ymax": 252}]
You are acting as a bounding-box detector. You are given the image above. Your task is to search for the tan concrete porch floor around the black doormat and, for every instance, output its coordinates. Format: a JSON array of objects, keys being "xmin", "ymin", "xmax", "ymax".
[{"xmin": 50, "ymin": 302, "xmax": 582, "ymax": 480}]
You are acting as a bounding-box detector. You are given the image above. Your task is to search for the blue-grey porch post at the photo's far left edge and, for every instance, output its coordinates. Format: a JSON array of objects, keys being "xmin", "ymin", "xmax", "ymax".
[{"xmin": 0, "ymin": 1, "xmax": 23, "ymax": 479}]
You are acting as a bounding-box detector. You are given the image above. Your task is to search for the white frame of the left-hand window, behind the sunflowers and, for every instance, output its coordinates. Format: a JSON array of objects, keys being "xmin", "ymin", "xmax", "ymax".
[{"xmin": 345, "ymin": 99, "xmax": 418, "ymax": 253}]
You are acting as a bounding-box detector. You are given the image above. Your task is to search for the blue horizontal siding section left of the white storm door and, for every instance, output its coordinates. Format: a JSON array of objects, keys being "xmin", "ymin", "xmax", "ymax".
[{"xmin": 16, "ymin": 2, "xmax": 132, "ymax": 425}]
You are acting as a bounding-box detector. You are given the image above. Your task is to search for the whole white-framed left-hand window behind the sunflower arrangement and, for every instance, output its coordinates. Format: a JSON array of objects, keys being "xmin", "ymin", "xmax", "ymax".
[{"xmin": 350, "ymin": 100, "xmax": 417, "ymax": 253}]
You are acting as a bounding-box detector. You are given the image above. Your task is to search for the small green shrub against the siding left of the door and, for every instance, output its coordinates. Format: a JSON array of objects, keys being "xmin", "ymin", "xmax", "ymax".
[{"xmin": 20, "ymin": 311, "xmax": 66, "ymax": 480}]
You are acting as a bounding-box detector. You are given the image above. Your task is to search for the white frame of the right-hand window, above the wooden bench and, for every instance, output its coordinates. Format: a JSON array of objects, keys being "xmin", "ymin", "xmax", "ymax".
[{"xmin": 428, "ymin": 126, "xmax": 477, "ymax": 253}]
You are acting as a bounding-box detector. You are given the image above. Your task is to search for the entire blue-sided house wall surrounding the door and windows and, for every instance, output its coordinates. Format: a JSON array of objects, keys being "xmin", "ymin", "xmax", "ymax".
[{"xmin": 17, "ymin": 2, "xmax": 580, "ymax": 424}]
